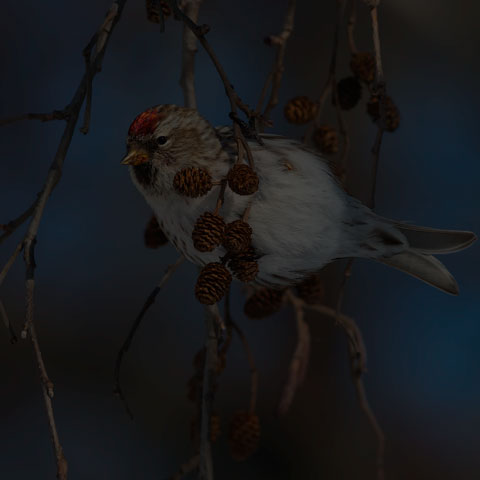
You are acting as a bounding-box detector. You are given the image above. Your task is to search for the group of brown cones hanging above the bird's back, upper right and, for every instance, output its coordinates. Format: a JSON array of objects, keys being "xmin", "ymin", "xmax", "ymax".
[{"xmin": 284, "ymin": 52, "xmax": 400, "ymax": 155}]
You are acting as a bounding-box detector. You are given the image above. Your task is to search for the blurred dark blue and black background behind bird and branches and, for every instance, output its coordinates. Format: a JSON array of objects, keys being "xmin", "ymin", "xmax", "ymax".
[{"xmin": 0, "ymin": 0, "xmax": 480, "ymax": 480}]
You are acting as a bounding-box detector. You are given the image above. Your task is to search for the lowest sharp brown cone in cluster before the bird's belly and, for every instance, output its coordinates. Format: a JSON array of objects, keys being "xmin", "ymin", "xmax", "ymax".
[{"xmin": 195, "ymin": 262, "xmax": 232, "ymax": 305}]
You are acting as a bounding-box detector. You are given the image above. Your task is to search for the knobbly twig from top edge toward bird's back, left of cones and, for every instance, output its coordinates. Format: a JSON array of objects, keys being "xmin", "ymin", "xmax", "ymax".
[{"xmin": 255, "ymin": 0, "xmax": 296, "ymax": 131}]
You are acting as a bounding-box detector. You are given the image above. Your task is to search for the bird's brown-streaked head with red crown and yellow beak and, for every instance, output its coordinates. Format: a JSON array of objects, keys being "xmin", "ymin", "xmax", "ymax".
[{"xmin": 122, "ymin": 105, "xmax": 222, "ymax": 194}]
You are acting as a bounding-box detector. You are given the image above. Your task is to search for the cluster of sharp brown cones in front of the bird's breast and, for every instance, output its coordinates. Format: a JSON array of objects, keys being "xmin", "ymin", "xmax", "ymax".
[{"xmin": 173, "ymin": 163, "xmax": 258, "ymax": 305}]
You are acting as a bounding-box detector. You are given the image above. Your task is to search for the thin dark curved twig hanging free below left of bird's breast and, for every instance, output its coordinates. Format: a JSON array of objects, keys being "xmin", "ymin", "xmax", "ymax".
[{"xmin": 113, "ymin": 255, "xmax": 185, "ymax": 420}]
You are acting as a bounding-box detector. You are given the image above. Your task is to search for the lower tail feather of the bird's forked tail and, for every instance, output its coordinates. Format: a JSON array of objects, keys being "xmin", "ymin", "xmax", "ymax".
[{"xmin": 378, "ymin": 250, "xmax": 458, "ymax": 295}]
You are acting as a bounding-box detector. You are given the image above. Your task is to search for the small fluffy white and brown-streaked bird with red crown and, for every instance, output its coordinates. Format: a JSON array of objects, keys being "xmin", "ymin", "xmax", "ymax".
[{"xmin": 121, "ymin": 104, "xmax": 476, "ymax": 295}]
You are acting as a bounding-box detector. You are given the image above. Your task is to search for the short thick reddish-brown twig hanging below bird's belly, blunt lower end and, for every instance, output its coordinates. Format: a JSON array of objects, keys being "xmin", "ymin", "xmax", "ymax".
[{"xmin": 278, "ymin": 290, "xmax": 310, "ymax": 415}]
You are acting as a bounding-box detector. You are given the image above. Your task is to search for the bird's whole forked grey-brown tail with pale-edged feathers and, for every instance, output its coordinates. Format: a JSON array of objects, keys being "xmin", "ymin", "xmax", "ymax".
[{"xmin": 378, "ymin": 223, "xmax": 477, "ymax": 295}]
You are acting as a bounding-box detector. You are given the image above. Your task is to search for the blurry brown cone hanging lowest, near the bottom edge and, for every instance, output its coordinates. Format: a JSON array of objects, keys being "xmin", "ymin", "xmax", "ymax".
[{"xmin": 229, "ymin": 410, "xmax": 260, "ymax": 461}]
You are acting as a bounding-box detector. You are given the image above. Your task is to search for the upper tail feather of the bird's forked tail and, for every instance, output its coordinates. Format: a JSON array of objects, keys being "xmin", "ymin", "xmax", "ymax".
[{"xmin": 396, "ymin": 223, "xmax": 477, "ymax": 254}]
